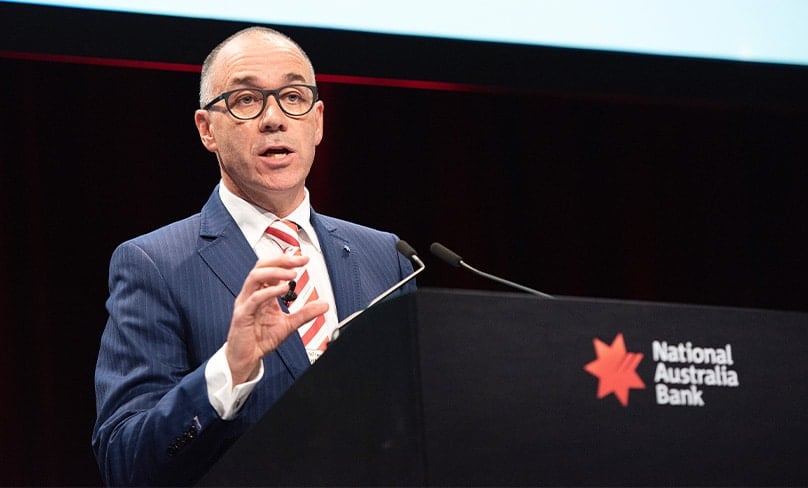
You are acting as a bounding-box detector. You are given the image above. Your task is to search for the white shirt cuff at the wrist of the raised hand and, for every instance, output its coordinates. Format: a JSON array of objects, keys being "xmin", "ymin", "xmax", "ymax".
[{"xmin": 205, "ymin": 342, "xmax": 264, "ymax": 420}]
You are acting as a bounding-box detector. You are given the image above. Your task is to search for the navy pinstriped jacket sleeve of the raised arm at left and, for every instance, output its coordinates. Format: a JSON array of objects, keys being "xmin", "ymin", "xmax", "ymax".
[{"xmin": 93, "ymin": 243, "xmax": 240, "ymax": 485}]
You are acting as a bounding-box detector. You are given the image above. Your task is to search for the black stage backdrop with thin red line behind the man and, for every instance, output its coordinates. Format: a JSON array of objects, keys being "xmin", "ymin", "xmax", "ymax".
[{"xmin": 0, "ymin": 4, "xmax": 808, "ymax": 485}]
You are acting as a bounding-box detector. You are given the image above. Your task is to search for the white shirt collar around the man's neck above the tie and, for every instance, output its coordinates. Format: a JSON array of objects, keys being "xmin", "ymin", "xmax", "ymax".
[{"xmin": 219, "ymin": 181, "xmax": 322, "ymax": 252}]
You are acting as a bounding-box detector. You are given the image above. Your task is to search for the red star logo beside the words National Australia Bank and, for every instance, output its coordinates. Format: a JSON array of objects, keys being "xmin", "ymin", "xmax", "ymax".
[{"xmin": 584, "ymin": 333, "xmax": 645, "ymax": 407}]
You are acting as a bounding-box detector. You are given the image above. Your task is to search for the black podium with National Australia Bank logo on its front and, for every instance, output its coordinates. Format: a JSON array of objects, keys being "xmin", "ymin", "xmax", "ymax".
[{"xmin": 200, "ymin": 289, "xmax": 808, "ymax": 486}]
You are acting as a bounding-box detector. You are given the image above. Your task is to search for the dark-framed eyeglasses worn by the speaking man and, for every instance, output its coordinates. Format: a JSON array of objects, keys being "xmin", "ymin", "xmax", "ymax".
[{"xmin": 203, "ymin": 84, "xmax": 317, "ymax": 120}]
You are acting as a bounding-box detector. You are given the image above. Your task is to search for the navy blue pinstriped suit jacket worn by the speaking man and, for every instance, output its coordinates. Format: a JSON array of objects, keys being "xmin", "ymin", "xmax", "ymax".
[{"xmin": 93, "ymin": 188, "xmax": 412, "ymax": 485}]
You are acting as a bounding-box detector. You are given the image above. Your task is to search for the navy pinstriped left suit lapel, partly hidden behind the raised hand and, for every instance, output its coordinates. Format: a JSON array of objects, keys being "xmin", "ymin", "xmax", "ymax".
[{"xmin": 198, "ymin": 186, "xmax": 310, "ymax": 378}]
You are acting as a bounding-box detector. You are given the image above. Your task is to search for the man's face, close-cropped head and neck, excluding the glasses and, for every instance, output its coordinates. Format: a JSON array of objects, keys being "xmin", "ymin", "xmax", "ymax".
[{"xmin": 196, "ymin": 34, "xmax": 323, "ymax": 217}]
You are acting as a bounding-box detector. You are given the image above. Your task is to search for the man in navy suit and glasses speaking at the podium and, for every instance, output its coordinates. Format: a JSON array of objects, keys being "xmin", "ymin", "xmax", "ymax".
[{"xmin": 93, "ymin": 28, "xmax": 412, "ymax": 485}]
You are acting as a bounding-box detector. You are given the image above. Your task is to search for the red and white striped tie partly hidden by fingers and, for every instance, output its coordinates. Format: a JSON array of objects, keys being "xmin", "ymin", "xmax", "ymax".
[{"xmin": 266, "ymin": 220, "xmax": 328, "ymax": 363}]
